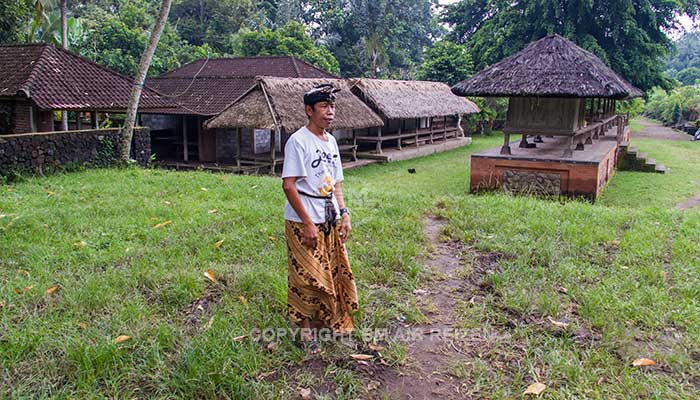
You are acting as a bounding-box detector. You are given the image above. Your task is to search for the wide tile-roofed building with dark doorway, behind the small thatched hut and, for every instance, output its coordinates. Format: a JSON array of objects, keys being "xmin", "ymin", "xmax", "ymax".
[{"xmin": 142, "ymin": 56, "xmax": 338, "ymax": 168}]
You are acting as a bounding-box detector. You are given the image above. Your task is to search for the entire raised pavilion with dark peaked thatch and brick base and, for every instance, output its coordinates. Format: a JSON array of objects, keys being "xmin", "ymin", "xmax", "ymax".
[{"xmin": 452, "ymin": 35, "xmax": 648, "ymax": 199}]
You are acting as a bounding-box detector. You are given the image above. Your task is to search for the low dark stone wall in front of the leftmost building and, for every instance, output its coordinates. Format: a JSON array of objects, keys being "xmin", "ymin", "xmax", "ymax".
[{"xmin": 0, "ymin": 128, "xmax": 151, "ymax": 176}]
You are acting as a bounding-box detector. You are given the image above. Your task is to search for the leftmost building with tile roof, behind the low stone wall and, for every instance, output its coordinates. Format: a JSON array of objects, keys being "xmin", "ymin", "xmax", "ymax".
[{"xmin": 0, "ymin": 44, "xmax": 172, "ymax": 135}]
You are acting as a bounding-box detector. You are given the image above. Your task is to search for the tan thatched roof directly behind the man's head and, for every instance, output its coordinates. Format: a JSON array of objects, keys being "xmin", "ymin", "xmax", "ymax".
[{"xmin": 205, "ymin": 77, "xmax": 384, "ymax": 132}]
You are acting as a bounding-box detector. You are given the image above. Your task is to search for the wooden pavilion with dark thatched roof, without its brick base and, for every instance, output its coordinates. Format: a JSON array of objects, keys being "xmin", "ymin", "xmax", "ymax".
[{"xmin": 452, "ymin": 35, "xmax": 643, "ymax": 158}]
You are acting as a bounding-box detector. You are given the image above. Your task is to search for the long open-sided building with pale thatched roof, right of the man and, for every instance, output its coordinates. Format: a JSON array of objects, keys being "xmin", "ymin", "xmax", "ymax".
[{"xmin": 350, "ymin": 78, "xmax": 480, "ymax": 154}]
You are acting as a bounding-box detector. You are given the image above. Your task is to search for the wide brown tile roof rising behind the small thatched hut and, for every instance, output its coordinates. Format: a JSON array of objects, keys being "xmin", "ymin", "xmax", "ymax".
[{"xmin": 146, "ymin": 56, "xmax": 338, "ymax": 115}]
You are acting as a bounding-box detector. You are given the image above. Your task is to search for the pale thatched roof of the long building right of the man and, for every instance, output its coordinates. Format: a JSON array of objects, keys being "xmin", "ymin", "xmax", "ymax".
[{"xmin": 350, "ymin": 78, "xmax": 480, "ymax": 119}]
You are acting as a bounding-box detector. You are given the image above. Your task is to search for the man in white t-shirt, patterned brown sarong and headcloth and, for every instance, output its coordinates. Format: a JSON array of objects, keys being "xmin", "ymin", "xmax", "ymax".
[{"xmin": 282, "ymin": 84, "xmax": 358, "ymax": 354}]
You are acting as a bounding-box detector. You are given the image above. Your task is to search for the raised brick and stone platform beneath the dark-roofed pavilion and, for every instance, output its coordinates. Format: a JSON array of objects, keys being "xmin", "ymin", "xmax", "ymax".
[{"xmin": 470, "ymin": 132, "xmax": 628, "ymax": 200}]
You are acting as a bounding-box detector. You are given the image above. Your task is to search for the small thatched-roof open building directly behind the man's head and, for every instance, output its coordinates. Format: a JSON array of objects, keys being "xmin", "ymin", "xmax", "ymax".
[{"xmin": 205, "ymin": 77, "xmax": 383, "ymax": 172}]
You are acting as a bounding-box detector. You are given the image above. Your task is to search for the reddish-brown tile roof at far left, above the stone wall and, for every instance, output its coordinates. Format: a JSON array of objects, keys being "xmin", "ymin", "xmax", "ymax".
[{"xmin": 0, "ymin": 44, "xmax": 173, "ymax": 111}]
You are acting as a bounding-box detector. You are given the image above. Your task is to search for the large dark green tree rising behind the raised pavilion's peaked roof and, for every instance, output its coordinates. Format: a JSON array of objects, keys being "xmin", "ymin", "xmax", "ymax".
[{"xmin": 443, "ymin": 0, "xmax": 700, "ymax": 90}]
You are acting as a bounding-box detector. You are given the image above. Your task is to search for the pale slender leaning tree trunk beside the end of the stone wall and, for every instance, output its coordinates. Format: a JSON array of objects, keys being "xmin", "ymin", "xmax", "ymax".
[{"xmin": 120, "ymin": 0, "xmax": 172, "ymax": 162}]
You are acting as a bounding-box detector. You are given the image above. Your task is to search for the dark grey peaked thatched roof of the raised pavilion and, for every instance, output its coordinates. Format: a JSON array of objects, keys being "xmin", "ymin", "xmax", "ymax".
[{"xmin": 452, "ymin": 35, "xmax": 643, "ymax": 99}]
